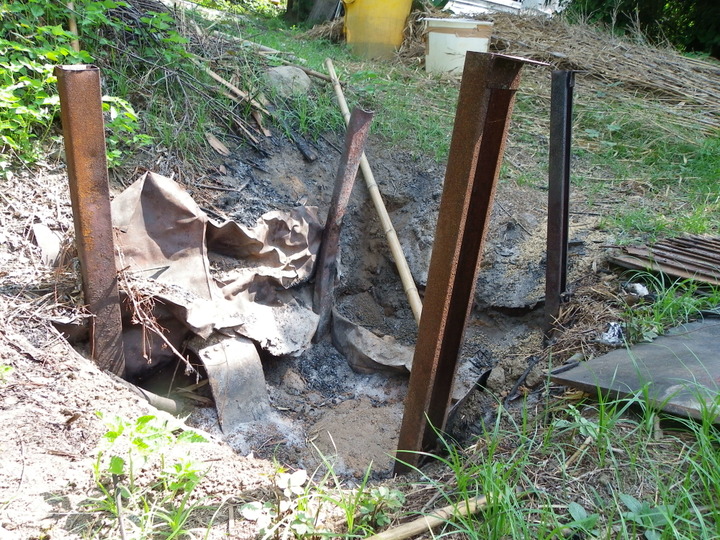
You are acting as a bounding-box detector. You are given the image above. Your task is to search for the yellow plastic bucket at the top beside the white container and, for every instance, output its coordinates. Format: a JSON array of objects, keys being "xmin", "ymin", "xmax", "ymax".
[{"xmin": 343, "ymin": 0, "xmax": 412, "ymax": 58}]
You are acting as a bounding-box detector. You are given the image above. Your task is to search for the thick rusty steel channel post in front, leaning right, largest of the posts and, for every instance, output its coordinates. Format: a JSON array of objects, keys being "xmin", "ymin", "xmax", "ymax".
[{"xmin": 395, "ymin": 52, "xmax": 527, "ymax": 473}]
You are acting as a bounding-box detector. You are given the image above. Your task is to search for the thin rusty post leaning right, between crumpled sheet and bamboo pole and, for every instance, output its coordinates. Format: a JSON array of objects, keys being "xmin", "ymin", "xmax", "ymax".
[{"xmin": 313, "ymin": 108, "xmax": 373, "ymax": 342}]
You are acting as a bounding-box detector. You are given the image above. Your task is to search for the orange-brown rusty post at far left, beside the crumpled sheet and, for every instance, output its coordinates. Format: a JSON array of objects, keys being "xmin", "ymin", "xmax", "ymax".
[{"xmin": 55, "ymin": 65, "xmax": 125, "ymax": 376}]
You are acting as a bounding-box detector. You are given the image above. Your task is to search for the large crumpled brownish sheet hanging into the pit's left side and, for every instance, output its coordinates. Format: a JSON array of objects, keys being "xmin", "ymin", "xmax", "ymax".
[{"xmin": 112, "ymin": 173, "xmax": 322, "ymax": 356}]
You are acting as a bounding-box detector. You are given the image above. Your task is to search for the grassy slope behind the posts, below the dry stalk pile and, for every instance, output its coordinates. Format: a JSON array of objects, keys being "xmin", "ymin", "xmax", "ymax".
[{"xmin": 232, "ymin": 12, "xmax": 720, "ymax": 242}]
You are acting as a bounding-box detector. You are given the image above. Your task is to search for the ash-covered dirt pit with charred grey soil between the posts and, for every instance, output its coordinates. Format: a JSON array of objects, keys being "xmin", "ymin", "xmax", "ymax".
[{"xmin": 124, "ymin": 124, "xmax": 605, "ymax": 478}]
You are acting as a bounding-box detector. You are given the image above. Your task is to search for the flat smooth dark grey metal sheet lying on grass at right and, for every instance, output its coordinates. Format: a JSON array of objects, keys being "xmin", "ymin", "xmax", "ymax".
[{"xmin": 550, "ymin": 319, "xmax": 720, "ymax": 423}]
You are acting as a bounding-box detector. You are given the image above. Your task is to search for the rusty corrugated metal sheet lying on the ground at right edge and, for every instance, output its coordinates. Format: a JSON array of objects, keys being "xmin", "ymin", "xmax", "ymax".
[{"xmin": 610, "ymin": 236, "xmax": 720, "ymax": 285}]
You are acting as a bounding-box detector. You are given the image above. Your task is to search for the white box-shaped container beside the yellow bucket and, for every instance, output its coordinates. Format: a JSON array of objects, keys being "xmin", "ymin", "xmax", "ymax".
[{"xmin": 424, "ymin": 18, "xmax": 492, "ymax": 75}]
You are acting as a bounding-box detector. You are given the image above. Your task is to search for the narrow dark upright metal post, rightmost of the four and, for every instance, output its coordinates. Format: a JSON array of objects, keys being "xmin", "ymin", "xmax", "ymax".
[{"xmin": 544, "ymin": 70, "xmax": 575, "ymax": 340}]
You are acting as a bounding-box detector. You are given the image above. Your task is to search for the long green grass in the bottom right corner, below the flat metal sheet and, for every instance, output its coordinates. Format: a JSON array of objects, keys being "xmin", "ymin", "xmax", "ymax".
[{"xmin": 394, "ymin": 392, "xmax": 720, "ymax": 539}]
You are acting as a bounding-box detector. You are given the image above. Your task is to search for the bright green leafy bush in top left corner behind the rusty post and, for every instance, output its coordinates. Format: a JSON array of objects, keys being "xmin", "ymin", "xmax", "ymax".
[{"xmin": 0, "ymin": 0, "xmax": 148, "ymax": 175}]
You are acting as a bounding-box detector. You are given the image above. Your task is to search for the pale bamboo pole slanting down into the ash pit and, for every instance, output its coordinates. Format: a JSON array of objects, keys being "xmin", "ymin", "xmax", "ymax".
[{"xmin": 325, "ymin": 58, "xmax": 422, "ymax": 324}]
